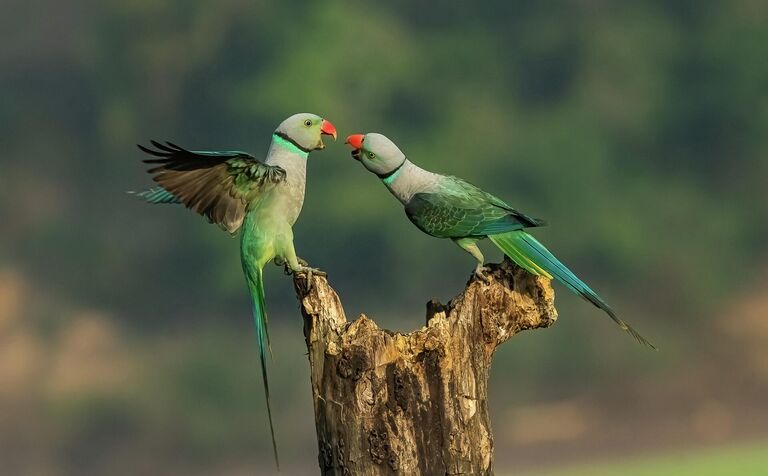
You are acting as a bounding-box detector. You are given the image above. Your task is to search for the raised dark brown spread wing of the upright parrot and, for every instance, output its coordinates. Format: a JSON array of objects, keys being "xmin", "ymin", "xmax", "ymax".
[{"xmin": 138, "ymin": 141, "xmax": 286, "ymax": 233}]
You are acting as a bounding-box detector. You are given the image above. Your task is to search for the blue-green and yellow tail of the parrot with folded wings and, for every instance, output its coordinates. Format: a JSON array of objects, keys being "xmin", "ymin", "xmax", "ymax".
[{"xmin": 488, "ymin": 230, "xmax": 656, "ymax": 349}]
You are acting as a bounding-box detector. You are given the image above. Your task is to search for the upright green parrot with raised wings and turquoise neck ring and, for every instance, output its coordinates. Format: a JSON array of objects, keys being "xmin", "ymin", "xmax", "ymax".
[{"xmin": 137, "ymin": 113, "xmax": 336, "ymax": 467}]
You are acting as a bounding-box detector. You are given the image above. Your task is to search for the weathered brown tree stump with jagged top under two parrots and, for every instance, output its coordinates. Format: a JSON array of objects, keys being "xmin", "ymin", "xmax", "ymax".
[{"xmin": 294, "ymin": 260, "xmax": 557, "ymax": 476}]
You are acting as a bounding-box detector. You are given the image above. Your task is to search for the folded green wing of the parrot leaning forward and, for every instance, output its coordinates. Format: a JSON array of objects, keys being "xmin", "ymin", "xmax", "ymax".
[{"xmin": 405, "ymin": 177, "xmax": 546, "ymax": 238}]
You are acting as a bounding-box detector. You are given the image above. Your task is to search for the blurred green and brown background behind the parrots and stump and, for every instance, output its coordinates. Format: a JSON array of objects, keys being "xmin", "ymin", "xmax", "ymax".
[{"xmin": 0, "ymin": 0, "xmax": 768, "ymax": 475}]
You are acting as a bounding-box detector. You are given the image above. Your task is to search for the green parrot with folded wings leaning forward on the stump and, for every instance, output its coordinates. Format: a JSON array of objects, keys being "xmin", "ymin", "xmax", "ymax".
[{"xmin": 346, "ymin": 133, "xmax": 655, "ymax": 349}]
